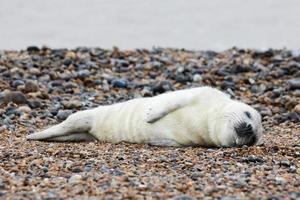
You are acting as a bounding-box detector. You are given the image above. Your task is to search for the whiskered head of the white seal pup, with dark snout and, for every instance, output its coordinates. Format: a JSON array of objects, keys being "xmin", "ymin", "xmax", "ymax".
[{"xmin": 216, "ymin": 101, "xmax": 263, "ymax": 147}]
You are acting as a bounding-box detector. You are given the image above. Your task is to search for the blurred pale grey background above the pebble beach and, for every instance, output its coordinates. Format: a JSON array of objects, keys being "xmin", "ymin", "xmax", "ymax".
[{"xmin": 0, "ymin": 0, "xmax": 300, "ymax": 51}]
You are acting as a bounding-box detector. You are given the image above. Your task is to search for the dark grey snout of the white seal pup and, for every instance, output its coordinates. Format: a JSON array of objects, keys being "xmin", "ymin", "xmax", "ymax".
[{"xmin": 234, "ymin": 122, "xmax": 257, "ymax": 146}]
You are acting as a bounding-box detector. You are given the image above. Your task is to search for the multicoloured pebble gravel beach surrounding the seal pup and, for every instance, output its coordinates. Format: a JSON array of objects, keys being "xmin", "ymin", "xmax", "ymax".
[{"xmin": 0, "ymin": 46, "xmax": 300, "ymax": 199}]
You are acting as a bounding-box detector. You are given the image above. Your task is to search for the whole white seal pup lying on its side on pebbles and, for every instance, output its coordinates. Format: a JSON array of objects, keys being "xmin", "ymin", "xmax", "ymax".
[{"xmin": 27, "ymin": 87, "xmax": 262, "ymax": 147}]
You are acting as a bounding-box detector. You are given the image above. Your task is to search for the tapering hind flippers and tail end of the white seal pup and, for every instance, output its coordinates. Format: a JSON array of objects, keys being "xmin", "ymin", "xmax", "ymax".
[{"xmin": 26, "ymin": 110, "xmax": 95, "ymax": 141}]
